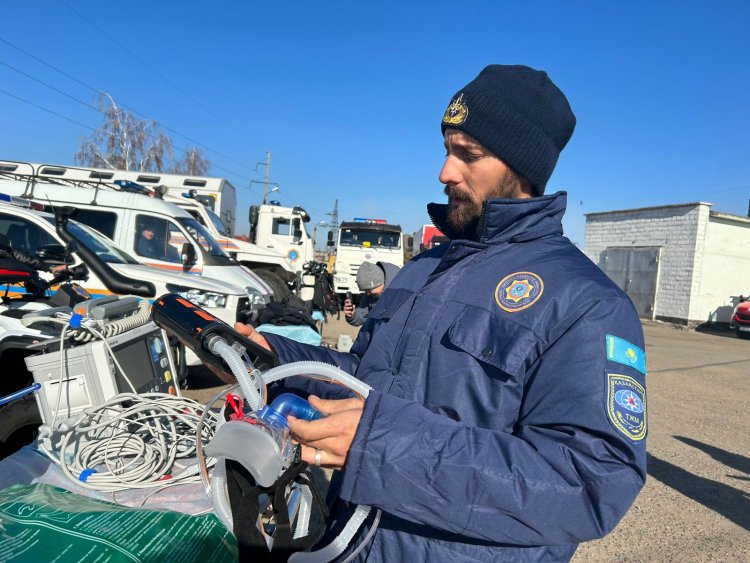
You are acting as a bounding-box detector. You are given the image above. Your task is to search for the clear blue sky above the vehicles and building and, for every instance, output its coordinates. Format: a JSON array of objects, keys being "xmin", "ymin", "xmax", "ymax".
[{"xmin": 0, "ymin": 0, "xmax": 750, "ymax": 245}]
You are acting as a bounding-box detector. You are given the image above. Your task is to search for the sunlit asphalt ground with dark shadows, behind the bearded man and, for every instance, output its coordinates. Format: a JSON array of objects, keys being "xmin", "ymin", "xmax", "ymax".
[{"xmin": 184, "ymin": 316, "xmax": 750, "ymax": 563}]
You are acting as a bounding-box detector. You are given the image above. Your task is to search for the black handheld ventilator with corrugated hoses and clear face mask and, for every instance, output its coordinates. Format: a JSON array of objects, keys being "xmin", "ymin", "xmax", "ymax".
[{"xmin": 152, "ymin": 294, "xmax": 377, "ymax": 563}]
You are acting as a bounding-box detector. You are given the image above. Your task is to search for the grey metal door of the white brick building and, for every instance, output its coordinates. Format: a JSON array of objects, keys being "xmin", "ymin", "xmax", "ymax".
[{"xmin": 604, "ymin": 247, "xmax": 660, "ymax": 319}]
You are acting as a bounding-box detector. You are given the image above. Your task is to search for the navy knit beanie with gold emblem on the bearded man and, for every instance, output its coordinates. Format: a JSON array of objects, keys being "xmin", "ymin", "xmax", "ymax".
[{"xmin": 442, "ymin": 65, "xmax": 576, "ymax": 196}]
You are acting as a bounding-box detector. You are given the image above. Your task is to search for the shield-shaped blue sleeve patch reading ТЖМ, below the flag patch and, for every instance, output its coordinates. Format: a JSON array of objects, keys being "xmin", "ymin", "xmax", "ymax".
[{"xmin": 607, "ymin": 373, "xmax": 648, "ymax": 442}]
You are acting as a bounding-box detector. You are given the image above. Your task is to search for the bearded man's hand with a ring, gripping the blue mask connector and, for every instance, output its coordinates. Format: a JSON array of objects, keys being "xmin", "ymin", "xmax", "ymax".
[{"xmin": 287, "ymin": 395, "xmax": 365, "ymax": 469}]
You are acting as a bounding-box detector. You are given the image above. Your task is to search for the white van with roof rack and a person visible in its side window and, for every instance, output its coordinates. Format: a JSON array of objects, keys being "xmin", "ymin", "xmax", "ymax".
[{"xmin": 0, "ymin": 161, "xmax": 271, "ymax": 310}]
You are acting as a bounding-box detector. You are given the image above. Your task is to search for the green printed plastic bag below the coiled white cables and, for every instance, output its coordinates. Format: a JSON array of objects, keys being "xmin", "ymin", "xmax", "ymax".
[{"xmin": 0, "ymin": 484, "xmax": 238, "ymax": 563}]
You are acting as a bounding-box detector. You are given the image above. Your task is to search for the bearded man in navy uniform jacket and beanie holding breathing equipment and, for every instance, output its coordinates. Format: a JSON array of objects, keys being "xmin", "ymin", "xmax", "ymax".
[{"xmin": 231, "ymin": 65, "xmax": 646, "ymax": 561}]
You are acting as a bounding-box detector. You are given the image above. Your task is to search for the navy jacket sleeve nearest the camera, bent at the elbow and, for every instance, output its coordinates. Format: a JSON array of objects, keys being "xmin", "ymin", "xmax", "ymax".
[{"xmin": 340, "ymin": 298, "xmax": 646, "ymax": 546}]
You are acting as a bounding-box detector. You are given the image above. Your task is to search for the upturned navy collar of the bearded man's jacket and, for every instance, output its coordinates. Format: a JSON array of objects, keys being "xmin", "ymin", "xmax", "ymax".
[{"xmin": 427, "ymin": 192, "xmax": 568, "ymax": 244}]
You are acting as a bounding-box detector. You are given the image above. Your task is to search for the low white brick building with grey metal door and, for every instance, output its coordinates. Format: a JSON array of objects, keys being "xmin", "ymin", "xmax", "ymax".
[{"xmin": 584, "ymin": 202, "xmax": 750, "ymax": 327}]
